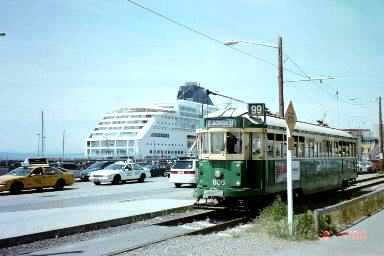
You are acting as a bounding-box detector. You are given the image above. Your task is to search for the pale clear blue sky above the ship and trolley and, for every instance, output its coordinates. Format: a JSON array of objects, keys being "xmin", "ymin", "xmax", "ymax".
[{"xmin": 0, "ymin": 0, "xmax": 384, "ymax": 152}]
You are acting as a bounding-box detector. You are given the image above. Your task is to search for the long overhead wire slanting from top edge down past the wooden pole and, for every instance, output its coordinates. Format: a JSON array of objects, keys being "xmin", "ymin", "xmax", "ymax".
[{"xmin": 127, "ymin": 0, "xmax": 308, "ymax": 77}]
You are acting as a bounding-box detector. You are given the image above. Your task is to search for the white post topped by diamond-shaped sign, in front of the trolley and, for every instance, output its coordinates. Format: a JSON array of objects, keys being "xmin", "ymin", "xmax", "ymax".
[{"xmin": 284, "ymin": 101, "xmax": 297, "ymax": 235}]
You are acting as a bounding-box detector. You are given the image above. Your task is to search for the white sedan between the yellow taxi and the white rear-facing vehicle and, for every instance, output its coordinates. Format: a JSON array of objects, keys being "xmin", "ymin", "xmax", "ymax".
[{"xmin": 89, "ymin": 161, "xmax": 146, "ymax": 185}]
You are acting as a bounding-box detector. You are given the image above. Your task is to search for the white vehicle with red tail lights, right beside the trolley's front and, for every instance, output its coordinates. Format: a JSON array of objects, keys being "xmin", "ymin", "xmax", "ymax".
[{"xmin": 169, "ymin": 160, "xmax": 198, "ymax": 188}]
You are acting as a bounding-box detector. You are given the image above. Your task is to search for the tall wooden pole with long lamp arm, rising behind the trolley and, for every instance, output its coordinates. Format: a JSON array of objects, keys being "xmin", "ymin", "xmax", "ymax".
[{"xmin": 224, "ymin": 36, "xmax": 284, "ymax": 118}]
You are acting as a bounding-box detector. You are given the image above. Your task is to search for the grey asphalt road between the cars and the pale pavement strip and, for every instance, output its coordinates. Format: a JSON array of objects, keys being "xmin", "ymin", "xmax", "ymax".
[{"xmin": 0, "ymin": 177, "xmax": 193, "ymax": 213}]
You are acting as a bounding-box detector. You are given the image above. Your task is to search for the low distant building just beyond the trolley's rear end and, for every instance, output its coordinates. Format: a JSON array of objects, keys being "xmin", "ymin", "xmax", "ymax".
[{"xmin": 343, "ymin": 129, "xmax": 378, "ymax": 159}]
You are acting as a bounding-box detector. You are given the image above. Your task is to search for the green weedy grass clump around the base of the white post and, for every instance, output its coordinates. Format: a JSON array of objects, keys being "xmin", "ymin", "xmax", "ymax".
[{"xmin": 252, "ymin": 200, "xmax": 318, "ymax": 241}]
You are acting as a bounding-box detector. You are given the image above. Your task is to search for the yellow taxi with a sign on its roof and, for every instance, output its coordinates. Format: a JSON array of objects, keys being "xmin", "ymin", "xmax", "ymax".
[{"xmin": 0, "ymin": 158, "xmax": 75, "ymax": 194}]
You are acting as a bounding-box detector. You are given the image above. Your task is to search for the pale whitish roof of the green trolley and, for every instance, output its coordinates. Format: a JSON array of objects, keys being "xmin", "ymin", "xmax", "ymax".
[{"xmin": 207, "ymin": 108, "xmax": 354, "ymax": 138}]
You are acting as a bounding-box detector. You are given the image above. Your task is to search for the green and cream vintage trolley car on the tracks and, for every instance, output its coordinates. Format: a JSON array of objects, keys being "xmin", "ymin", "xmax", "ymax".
[{"xmin": 194, "ymin": 109, "xmax": 358, "ymax": 203}]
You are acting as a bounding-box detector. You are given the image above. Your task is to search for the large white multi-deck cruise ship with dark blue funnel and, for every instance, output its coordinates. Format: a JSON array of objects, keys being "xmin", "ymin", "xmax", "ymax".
[{"xmin": 85, "ymin": 82, "xmax": 217, "ymax": 160}]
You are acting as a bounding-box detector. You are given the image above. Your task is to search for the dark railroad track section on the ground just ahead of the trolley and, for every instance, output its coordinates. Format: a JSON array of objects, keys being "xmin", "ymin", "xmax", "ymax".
[{"xmin": 103, "ymin": 210, "xmax": 251, "ymax": 256}]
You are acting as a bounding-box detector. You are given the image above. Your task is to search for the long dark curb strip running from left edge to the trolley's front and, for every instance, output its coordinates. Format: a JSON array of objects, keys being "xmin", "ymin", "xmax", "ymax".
[{"xmin": 0, "ymin": 205, "xmax": 193, "ymax": 248}]
